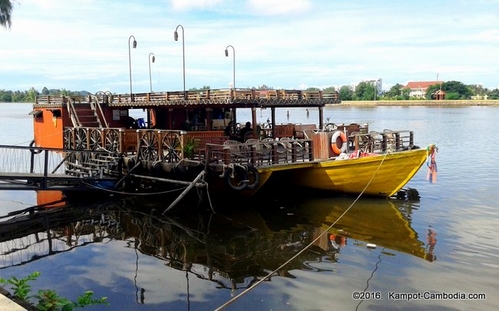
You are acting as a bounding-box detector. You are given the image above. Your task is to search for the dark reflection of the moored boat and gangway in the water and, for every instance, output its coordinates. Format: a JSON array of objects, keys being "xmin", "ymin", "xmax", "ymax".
[{"xmin": 0, "ymin": 190, "xmax": 436, "ymax": 302}]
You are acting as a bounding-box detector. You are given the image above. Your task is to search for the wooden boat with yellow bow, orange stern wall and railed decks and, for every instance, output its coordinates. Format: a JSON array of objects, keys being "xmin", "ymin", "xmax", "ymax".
[{"xmin": 31, "ymin": 89, "xmax": 427, "ymax": 202}]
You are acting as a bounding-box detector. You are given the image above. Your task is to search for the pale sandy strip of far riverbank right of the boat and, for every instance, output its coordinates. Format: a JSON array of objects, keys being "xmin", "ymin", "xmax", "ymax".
[{"xmin": 341, "ymin": 100, "xmax": 499, "ymax": 107}]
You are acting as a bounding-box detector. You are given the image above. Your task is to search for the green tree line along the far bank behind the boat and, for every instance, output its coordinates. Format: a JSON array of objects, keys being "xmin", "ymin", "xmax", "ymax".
[{"xmin": 0, "ymin": 81, "xmax": 499, "ymax": 103}]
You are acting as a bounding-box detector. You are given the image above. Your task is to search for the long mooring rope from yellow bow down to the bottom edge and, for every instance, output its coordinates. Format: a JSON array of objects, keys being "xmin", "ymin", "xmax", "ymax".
[{"xmin": 215, "ymin": 153, "xmax": 388, "ymax": 311}]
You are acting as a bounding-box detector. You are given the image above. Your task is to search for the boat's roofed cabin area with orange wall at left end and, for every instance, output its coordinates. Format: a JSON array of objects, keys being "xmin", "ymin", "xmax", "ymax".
[{"xmin": 31, "ymin": 90, "xmax": 339, "ymax": 152}]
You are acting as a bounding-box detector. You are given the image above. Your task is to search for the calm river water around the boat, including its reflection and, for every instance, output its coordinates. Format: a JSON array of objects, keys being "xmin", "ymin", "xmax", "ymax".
[{"xmin": 0, "ymin": 104, "xmax": 499, "ymax": 310}]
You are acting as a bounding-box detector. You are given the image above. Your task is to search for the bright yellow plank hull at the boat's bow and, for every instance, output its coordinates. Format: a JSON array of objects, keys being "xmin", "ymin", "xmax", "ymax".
[{"xmin": 287, "ymin": 149, "xmax": 427, "ymax": 197}]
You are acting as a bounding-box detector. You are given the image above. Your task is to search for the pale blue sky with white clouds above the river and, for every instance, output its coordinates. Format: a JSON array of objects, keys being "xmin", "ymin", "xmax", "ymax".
[{"xmin": 0, "ymin": 0, "xmax": 499, "ymax": 93}]
